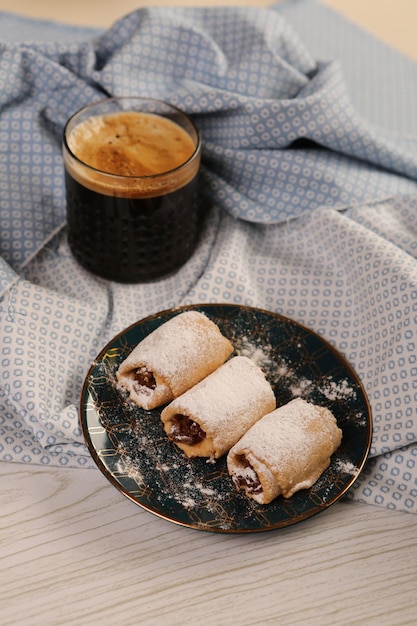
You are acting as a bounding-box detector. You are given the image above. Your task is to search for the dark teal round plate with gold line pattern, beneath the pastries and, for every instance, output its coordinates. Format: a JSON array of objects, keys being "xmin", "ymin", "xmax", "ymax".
[{"xmin": 80, "ymin": 304, "xmax": 372, "ymax": 533}]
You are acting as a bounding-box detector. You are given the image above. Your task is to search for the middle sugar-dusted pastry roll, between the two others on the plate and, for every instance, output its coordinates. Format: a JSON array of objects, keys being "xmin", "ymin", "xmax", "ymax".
[{"xmin": 161, "ymin": 356, "xmax": 276, "ymax": 459}]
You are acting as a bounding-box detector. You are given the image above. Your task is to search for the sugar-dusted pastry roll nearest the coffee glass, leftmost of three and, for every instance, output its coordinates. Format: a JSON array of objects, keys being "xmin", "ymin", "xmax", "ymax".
[{"xmin": 116, "ymin": 311, "xmax": 233, "ymax": 410}]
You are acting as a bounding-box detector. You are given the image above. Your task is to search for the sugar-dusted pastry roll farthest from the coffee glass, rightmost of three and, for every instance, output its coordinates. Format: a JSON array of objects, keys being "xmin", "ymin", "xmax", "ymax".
[{"xmin": 227, "ymin": 398, "xmax": 342, "ymax": 504}]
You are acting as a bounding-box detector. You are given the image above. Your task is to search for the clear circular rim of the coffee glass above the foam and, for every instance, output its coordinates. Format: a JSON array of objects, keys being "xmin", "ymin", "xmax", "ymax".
[{"xmin": 63, "ymin": 96, "xmax": 201, "ymax": 180}]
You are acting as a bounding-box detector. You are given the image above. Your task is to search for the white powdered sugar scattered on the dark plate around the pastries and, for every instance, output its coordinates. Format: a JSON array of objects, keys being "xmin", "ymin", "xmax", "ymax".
[{"xmin": 87, "ymin": 310, "xmax": 368, "ymax": 530}]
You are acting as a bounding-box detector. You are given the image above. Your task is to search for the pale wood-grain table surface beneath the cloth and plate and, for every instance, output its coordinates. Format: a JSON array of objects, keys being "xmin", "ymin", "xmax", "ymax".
[{"xmin": 0, "ymin": 0, "xmax": 417, "ymax": 626}]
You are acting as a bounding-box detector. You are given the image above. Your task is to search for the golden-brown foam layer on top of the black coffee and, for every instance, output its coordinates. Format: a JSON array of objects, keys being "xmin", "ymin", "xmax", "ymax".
[{"xmin": 64, "ymin": 111, "xmax": 200, "ymax": 197}]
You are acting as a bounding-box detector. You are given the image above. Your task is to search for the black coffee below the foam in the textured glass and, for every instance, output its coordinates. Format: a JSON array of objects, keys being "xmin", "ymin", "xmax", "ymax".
[{"xmin": 65, "ymin": 172, "xmax": 199, "ymax": 283}]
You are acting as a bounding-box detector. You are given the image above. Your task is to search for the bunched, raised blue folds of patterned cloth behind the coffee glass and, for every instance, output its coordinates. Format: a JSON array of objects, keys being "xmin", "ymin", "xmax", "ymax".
[{"xmin": 0, "ymin": 7, "xmax": 417, "ymax": 269}]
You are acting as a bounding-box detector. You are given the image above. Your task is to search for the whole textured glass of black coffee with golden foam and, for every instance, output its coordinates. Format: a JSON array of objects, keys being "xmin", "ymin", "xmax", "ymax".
[{"xmin": 63, "ymin": 97, "xmax": 201, "ymax": 283}]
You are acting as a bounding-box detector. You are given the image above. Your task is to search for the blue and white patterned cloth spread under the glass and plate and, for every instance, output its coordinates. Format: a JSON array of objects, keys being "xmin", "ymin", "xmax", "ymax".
[{"xmin": 0, "ymin": 0, "xmax": 417, "ymax": 513}]
